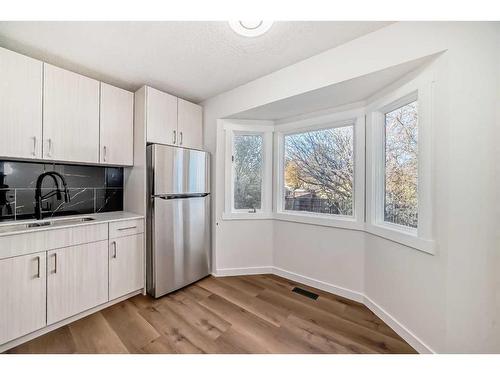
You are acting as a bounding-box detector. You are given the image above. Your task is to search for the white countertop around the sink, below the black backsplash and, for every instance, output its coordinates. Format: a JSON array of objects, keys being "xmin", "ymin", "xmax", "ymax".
[{"xmin": 0, "ymin": 211, "xmax": 144, "ymax": 236}]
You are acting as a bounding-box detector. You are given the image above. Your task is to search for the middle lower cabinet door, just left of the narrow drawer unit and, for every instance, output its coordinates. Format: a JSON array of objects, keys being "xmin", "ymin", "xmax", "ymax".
[{"xmin": 47, "ymin": 241, "xmax": 108, "ymax": 324}]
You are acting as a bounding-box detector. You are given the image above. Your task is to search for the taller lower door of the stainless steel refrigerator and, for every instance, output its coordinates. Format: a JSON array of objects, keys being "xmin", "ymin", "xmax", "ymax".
[{"xmin": 148, "ymin": 195, "xmax": 210, "ymax": 297}]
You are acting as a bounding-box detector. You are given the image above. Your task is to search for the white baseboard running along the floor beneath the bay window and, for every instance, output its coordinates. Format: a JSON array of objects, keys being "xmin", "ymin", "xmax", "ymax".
[{"xmin": 213, "ymin": 266, "xmax": 436, "ymax": 354}]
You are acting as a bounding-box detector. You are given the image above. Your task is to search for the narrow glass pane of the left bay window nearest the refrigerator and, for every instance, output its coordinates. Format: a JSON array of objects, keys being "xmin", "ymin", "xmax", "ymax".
[{"xmin": 234, "ymin": 134, "xmax": 262, "ymax": 210}]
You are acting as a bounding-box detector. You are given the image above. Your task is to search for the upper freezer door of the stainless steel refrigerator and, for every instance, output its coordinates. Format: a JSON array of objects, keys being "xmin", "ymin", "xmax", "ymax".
[{"xmin": 149, "ymin": 145, "xmax": 210, "ymax": 194}]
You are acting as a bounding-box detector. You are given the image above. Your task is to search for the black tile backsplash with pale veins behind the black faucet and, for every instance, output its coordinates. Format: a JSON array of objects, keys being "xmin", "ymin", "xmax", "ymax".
[{"xmin": 0, "ymin": 160, "xmax": 123, "ymax": 221}]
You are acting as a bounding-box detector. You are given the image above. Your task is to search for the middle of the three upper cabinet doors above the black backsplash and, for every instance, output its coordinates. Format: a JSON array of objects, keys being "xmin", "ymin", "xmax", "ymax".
[{"xmin": 43, "ymin": 64, "xmax": 99, "ymax": 163}]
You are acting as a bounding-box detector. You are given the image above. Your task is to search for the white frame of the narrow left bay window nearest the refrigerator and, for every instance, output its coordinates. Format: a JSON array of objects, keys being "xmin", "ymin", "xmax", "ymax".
[{"xmin": 223, "ymin": 120, "xmax": 274, "ymax": 220}]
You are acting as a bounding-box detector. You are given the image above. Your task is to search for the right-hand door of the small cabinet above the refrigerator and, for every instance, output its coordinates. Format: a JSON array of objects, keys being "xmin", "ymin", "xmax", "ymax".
[{"xmin": 177, "ymin": 99, "xmax": 203, "ymax": 150}]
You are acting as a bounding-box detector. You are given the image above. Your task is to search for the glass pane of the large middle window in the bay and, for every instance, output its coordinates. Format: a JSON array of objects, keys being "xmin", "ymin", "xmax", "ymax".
[{"xmin": 284, "ymin": 126, "xmax": 354, "ymax": 216}]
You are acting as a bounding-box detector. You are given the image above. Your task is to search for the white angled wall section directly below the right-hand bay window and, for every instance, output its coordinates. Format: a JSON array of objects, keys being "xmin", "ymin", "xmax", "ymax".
[{"xmin": 364, "ymin": 234, "xmax": 446, "ymax": 352}]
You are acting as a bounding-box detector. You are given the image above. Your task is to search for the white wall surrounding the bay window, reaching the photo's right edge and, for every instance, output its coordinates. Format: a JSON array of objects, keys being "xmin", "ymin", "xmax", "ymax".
[{"xmin": 203, "ymin": 22, "xmax": 500, "ymax": 352}]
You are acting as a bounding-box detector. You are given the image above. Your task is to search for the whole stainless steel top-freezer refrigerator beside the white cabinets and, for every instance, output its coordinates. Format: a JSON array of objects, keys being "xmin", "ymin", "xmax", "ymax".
[{"xmin": 147, "ymin": 144, "xmax": 211, "ymax": 297}]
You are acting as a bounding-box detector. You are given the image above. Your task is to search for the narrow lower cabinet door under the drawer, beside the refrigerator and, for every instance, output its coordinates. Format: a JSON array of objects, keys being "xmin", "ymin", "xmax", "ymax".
[{"xmin": 109, "ymin": 233, "xmax": 144, "ymax": 300}]
